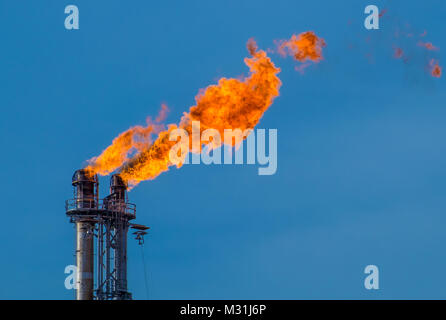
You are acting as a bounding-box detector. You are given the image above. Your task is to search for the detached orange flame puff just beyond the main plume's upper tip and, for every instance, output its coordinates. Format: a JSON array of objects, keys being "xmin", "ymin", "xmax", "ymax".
[{"xmin": 277, "ymin": 31, "xmax": 325, "ymax": 62}]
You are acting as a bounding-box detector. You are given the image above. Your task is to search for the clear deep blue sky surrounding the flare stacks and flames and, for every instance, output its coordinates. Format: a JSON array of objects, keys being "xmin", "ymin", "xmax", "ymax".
[{"xmin": 0, "ymin": 0, "xmax": 446, "ymax": 299}]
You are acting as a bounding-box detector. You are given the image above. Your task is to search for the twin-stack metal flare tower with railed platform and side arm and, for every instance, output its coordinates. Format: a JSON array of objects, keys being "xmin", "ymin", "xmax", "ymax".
[{"xmin": 65, "ymin": 169, "xmax": 149, "ymax": 300}]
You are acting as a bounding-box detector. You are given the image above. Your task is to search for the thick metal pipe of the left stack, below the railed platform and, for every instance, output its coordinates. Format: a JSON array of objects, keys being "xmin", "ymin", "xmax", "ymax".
[{"xmin": 76, "ymin": 220, "xmax": 94, "ymax": 300}]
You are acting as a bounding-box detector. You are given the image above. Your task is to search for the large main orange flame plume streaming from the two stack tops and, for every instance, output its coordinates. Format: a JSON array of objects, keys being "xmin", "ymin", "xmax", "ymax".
[{"xmin": 87, "ymin": 39, "xmax": 281, "ymax": 187}]
